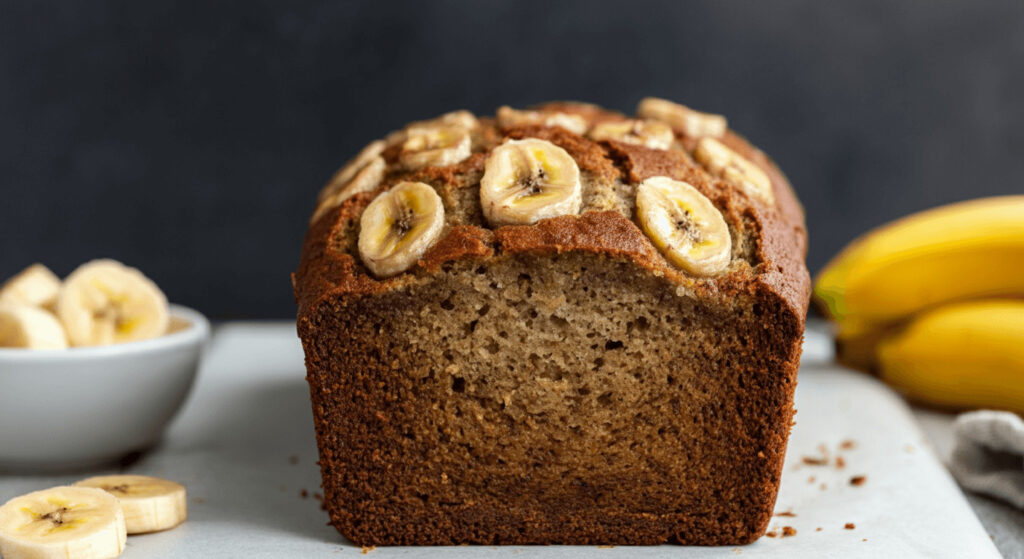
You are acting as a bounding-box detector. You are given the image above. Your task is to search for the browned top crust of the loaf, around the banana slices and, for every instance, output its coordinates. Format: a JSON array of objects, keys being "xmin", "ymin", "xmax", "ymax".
[{"xmin": 293, "ymin": 101, "xmax": 810, "ymax": 323}]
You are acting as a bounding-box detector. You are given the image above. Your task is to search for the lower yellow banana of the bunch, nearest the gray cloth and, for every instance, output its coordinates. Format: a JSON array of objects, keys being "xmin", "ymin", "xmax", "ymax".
[{"xmin": 877, "ymin": 299, "xmax": 1024, "ymax": 413}]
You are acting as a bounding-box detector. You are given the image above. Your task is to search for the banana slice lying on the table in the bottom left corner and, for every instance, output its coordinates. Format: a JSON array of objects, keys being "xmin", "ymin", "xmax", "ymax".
[{"xmin": 0, "ymin": 487, "xmax": 127, "ymax": 559}]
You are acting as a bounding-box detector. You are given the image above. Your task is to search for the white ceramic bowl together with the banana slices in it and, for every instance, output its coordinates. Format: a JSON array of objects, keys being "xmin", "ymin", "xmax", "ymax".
[{"xmin": 0, "ymin": 260, "xmax": 210, "ymax": 471}]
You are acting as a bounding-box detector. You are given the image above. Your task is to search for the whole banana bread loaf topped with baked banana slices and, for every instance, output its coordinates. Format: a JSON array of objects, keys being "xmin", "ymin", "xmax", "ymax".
[{"xmin": 293, "ymin": 99, "xmax": 809, "ymax": 546}]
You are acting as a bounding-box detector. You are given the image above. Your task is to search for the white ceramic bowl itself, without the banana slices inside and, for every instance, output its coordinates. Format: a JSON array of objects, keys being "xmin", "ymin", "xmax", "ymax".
[{"xmin": 0, "ymin": 305, "xmax": 210, "ymax": 473}]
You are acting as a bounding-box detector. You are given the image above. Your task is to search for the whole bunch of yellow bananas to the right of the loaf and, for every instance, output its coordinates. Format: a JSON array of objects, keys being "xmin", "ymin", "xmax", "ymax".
[{"xmin": 814, "ymin": 196, "xmax": 1024, "ymax": 413}]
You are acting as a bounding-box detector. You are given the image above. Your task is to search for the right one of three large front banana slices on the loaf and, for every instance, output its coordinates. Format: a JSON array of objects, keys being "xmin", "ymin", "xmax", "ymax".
[{"xmin": 637, "ymin": 177, "xmax": 732, "ymax": 275}]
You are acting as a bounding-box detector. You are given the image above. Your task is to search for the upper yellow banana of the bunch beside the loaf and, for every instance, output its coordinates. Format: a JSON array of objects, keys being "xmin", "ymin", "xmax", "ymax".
[{"xmin": 814, "ymin": 196, "xmax": 1024, "ymax": 324}]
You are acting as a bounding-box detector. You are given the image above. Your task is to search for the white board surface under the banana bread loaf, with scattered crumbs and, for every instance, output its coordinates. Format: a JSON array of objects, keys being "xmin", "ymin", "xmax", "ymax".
[{"xmin": 0, "ymin": 323, "xmax": 1014, "ymax": 559}]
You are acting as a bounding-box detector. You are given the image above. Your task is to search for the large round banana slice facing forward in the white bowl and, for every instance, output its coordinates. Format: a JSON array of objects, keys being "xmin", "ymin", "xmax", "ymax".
[{"xmin": 57, "ymin": 260, "xmax": 169, "ymax": 346}]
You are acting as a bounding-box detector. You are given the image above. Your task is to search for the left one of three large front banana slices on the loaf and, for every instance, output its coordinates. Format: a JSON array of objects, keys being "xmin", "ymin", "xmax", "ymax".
[{"xmin": 358, "ymin": 182, "xmax": 444, "ymax": 277}]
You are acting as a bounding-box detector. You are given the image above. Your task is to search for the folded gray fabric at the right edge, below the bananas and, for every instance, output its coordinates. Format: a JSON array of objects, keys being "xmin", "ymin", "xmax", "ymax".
[{"xmin": 949, "ymin": 410, "xmax": 1024, "ymax": 509}]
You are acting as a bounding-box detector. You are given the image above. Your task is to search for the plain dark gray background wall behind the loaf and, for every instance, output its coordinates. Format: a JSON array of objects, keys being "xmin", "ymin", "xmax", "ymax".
[{"xmin": 0, "ymin": 0, "xmax": 1024, "ymax": 318}]
